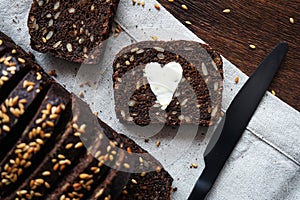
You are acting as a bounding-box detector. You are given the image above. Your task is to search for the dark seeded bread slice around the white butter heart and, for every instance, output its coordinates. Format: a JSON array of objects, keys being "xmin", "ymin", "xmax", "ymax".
[{"xmin": 113, "ymin": 41, "xmax": 223, "ymax": 126}]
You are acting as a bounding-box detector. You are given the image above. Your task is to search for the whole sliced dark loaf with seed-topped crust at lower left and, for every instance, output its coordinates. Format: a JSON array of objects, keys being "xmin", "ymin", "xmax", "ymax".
[{"xmin": 0, "ymin": 32, "xmax": 173, "ymax": 200}]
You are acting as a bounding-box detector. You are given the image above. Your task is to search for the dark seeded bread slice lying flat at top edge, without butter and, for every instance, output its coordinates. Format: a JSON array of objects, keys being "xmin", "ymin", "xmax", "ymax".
[{"xmin": 28, "ymin": 0, "xmax": 119, "ymax": 64}]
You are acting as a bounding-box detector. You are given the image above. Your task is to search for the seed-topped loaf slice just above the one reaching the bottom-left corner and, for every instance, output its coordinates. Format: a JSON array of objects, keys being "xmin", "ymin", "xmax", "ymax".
[{"xmin": 0, "ymin": 70, "xmax": 51, "ymax": 160}]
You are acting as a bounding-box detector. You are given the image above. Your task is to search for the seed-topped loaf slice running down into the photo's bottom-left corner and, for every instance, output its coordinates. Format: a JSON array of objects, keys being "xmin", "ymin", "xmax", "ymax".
[{"xmin": 0, "ymin": 84, "xmax": 70, "ymax": 198}]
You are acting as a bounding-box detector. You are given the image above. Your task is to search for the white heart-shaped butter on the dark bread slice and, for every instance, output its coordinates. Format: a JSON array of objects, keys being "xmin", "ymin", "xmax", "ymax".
[{"xmin": 145, "ymin": 62, "xmax": 183, "ymax": 110}]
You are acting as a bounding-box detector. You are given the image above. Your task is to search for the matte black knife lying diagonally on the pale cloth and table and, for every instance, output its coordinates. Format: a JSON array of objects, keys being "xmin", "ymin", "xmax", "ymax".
[{"xmin": 189, "ymin": 42, "xmax": 288, "ymax": 200}]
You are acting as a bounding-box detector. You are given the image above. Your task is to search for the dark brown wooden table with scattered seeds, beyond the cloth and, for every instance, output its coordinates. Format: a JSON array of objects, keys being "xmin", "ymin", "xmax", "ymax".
[{"xmin": 159, "ymin": 0, "xmax": 300, "ymax": 111}]
